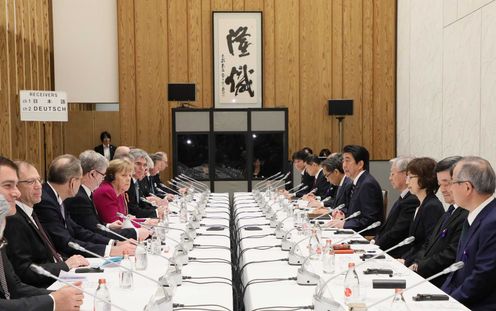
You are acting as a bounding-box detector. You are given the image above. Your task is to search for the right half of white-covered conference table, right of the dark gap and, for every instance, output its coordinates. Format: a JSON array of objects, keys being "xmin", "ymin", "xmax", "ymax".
[{"xmin": 233, "ymin": 193, "xmax": 469, "ymax": 311}]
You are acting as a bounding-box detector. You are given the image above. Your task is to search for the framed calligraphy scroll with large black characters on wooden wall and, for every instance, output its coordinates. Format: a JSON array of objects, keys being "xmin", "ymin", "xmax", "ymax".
[{"xmin": 212, "ymin": 12, "xmax": 263, "ymax": 108}]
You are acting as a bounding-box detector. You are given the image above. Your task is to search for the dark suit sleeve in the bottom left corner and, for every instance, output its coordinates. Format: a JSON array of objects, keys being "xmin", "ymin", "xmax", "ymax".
[{"xmin": 0, "ymin": 250, "xmax": 53, "ymax": 311}]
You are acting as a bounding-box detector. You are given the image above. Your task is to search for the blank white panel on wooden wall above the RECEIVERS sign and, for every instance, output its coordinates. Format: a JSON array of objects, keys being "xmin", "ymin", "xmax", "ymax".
[{"xmin": 52, "ymin": 0, "xmax": 119, "ymax": 103}]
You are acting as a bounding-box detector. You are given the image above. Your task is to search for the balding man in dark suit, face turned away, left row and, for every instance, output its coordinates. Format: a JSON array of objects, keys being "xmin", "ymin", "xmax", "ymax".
[{"xmin": 34, "ymin": 154, "xmax": 136, "ymax": 256}]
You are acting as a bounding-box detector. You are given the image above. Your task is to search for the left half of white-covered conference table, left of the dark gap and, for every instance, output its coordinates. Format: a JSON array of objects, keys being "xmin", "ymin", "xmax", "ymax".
[{"xmin": 50, "ymin": 194, "xmax": 233, "ymax": 311}]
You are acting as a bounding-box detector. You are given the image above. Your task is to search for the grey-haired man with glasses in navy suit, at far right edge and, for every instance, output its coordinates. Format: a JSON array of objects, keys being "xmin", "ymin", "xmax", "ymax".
[{"xmin": 442, "ymin": 157, "xmax": 496, "ymax": 311}]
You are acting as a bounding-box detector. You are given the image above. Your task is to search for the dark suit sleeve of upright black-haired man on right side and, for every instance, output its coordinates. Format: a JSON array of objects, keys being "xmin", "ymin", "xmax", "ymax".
[{"xmin": 344, "ymin": 176, "xmax": 384, "ymax": 231}]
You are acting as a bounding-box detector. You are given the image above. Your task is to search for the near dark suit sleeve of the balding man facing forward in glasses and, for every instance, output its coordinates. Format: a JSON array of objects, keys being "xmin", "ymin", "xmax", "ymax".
[{"xmin": 4, "ymin": 216, "xmax": 69, "ymax": 287}]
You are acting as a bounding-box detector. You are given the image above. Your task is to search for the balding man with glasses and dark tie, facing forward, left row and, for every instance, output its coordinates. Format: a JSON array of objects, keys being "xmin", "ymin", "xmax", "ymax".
[{"xmin": 4, "ymin": 161, "xmax": 89, "ymax": 288}]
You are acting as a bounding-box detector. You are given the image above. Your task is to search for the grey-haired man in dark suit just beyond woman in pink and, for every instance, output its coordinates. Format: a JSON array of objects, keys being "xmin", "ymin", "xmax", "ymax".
[{"xmin": 126, "ymin": 149, "xmax": 165, "ymax": 218}]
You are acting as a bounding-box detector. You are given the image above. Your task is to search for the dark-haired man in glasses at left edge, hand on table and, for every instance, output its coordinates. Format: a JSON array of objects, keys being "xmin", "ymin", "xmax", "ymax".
[{"xmin": 0, "ymin": 156, "xmax": 83, "ymax": 311}]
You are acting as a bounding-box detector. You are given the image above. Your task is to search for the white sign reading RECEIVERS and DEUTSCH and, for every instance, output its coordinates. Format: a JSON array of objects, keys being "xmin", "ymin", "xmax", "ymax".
[{"xmin": 19, "ymin": 90, "xmax": 68, "ymax": 122}]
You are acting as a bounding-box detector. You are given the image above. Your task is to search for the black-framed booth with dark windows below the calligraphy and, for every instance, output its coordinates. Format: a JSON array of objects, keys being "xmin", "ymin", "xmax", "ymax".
[{"xmin": 172, "ymin": 108, "xmax": 288, "ymax": 191}]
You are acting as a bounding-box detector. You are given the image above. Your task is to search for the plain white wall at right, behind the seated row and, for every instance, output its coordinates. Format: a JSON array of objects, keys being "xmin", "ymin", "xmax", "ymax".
[{"xmin": 397, "ymin": 0, "xmax": 496, "ymax": 168}]
